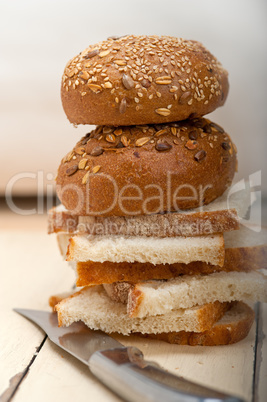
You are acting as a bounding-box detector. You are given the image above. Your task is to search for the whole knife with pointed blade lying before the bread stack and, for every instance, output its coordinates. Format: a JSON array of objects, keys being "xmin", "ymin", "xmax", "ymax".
[{"xmin": 14, "ymin": 309, "xmax": 244, "ymax": 402}]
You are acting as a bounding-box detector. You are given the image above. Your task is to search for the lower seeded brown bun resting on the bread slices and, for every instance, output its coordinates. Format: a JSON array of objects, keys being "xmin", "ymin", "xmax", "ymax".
[{"xmin": 57, "ymin": 118, "xmax": 236, "ymax": 216}]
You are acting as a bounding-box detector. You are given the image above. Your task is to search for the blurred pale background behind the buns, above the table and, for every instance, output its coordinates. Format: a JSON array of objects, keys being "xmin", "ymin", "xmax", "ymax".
[{"xmin": 0, "ymin": 0, "xmax": 267, "ymax": 225}]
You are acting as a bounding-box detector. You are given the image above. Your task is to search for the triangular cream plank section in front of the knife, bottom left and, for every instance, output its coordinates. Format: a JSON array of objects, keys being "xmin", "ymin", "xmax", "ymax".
[{"xmin": 13, "ymin": 341, "xmax": 120, "ymax": 402}]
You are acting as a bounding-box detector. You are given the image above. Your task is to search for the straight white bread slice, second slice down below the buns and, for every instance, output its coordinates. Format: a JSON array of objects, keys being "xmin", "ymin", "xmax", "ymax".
[{"xmin": 67, "ymin": 234, "xmax": 225, "ymax": 266}]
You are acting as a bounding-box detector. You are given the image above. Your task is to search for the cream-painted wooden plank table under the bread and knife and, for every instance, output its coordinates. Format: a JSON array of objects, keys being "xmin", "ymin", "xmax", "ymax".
[{"xmin": 0, "ymin": 217, "xmax": 267, "ymax": 402}]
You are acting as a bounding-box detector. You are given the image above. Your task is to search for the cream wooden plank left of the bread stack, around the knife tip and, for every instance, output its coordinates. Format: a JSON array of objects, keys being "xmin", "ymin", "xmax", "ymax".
[{"xmin": 0, "ymin": 231, "xmax": 74, "ymax": 395}]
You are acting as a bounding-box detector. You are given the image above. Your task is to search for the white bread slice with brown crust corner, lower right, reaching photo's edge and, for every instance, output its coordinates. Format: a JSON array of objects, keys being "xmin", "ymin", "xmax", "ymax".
[{"xmin": 107, "ymin": 271, "xmax": 267, "ymax": 317}]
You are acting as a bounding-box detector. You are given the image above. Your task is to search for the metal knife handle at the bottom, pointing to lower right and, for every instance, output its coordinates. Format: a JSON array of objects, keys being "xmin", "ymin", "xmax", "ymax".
[{"xmin": 88, "ymin": 347, "xmax": 244, "ymax": 402}]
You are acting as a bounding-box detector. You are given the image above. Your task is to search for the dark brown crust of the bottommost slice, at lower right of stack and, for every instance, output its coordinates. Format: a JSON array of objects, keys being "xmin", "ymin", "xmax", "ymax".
[{"xmin": 139, "ymin": 302, "xmax": 255, "ymax": 346}]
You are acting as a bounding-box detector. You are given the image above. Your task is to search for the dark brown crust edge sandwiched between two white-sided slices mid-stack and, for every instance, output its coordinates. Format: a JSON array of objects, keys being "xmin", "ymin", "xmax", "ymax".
[{"xmin": 76, "ymin": 245, "xmax": 267, "ymax": 286}]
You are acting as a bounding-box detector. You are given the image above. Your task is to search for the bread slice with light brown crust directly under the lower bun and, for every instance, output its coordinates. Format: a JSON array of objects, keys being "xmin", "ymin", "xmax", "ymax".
[{"xmin": 48, "ymin": 183, "xmax": 253, "ymax": 237}]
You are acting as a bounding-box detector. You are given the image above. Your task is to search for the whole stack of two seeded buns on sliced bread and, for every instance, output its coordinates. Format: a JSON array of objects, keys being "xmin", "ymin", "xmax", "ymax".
[{"xmin": 49, "ymin": 36, "xmax": 267, "ymax": 345}]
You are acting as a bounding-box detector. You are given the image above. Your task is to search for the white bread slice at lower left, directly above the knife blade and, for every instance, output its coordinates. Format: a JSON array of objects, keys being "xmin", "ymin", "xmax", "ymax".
[{"xmin": 55, "ymin": 286, "xmax": 230, "ymax": 335}]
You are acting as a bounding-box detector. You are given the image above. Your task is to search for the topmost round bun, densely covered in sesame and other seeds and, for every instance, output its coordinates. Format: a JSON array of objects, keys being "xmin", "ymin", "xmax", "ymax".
[{"xmin": 61, "ymin": 36, "xmax": 229, "ymax": 126}]
